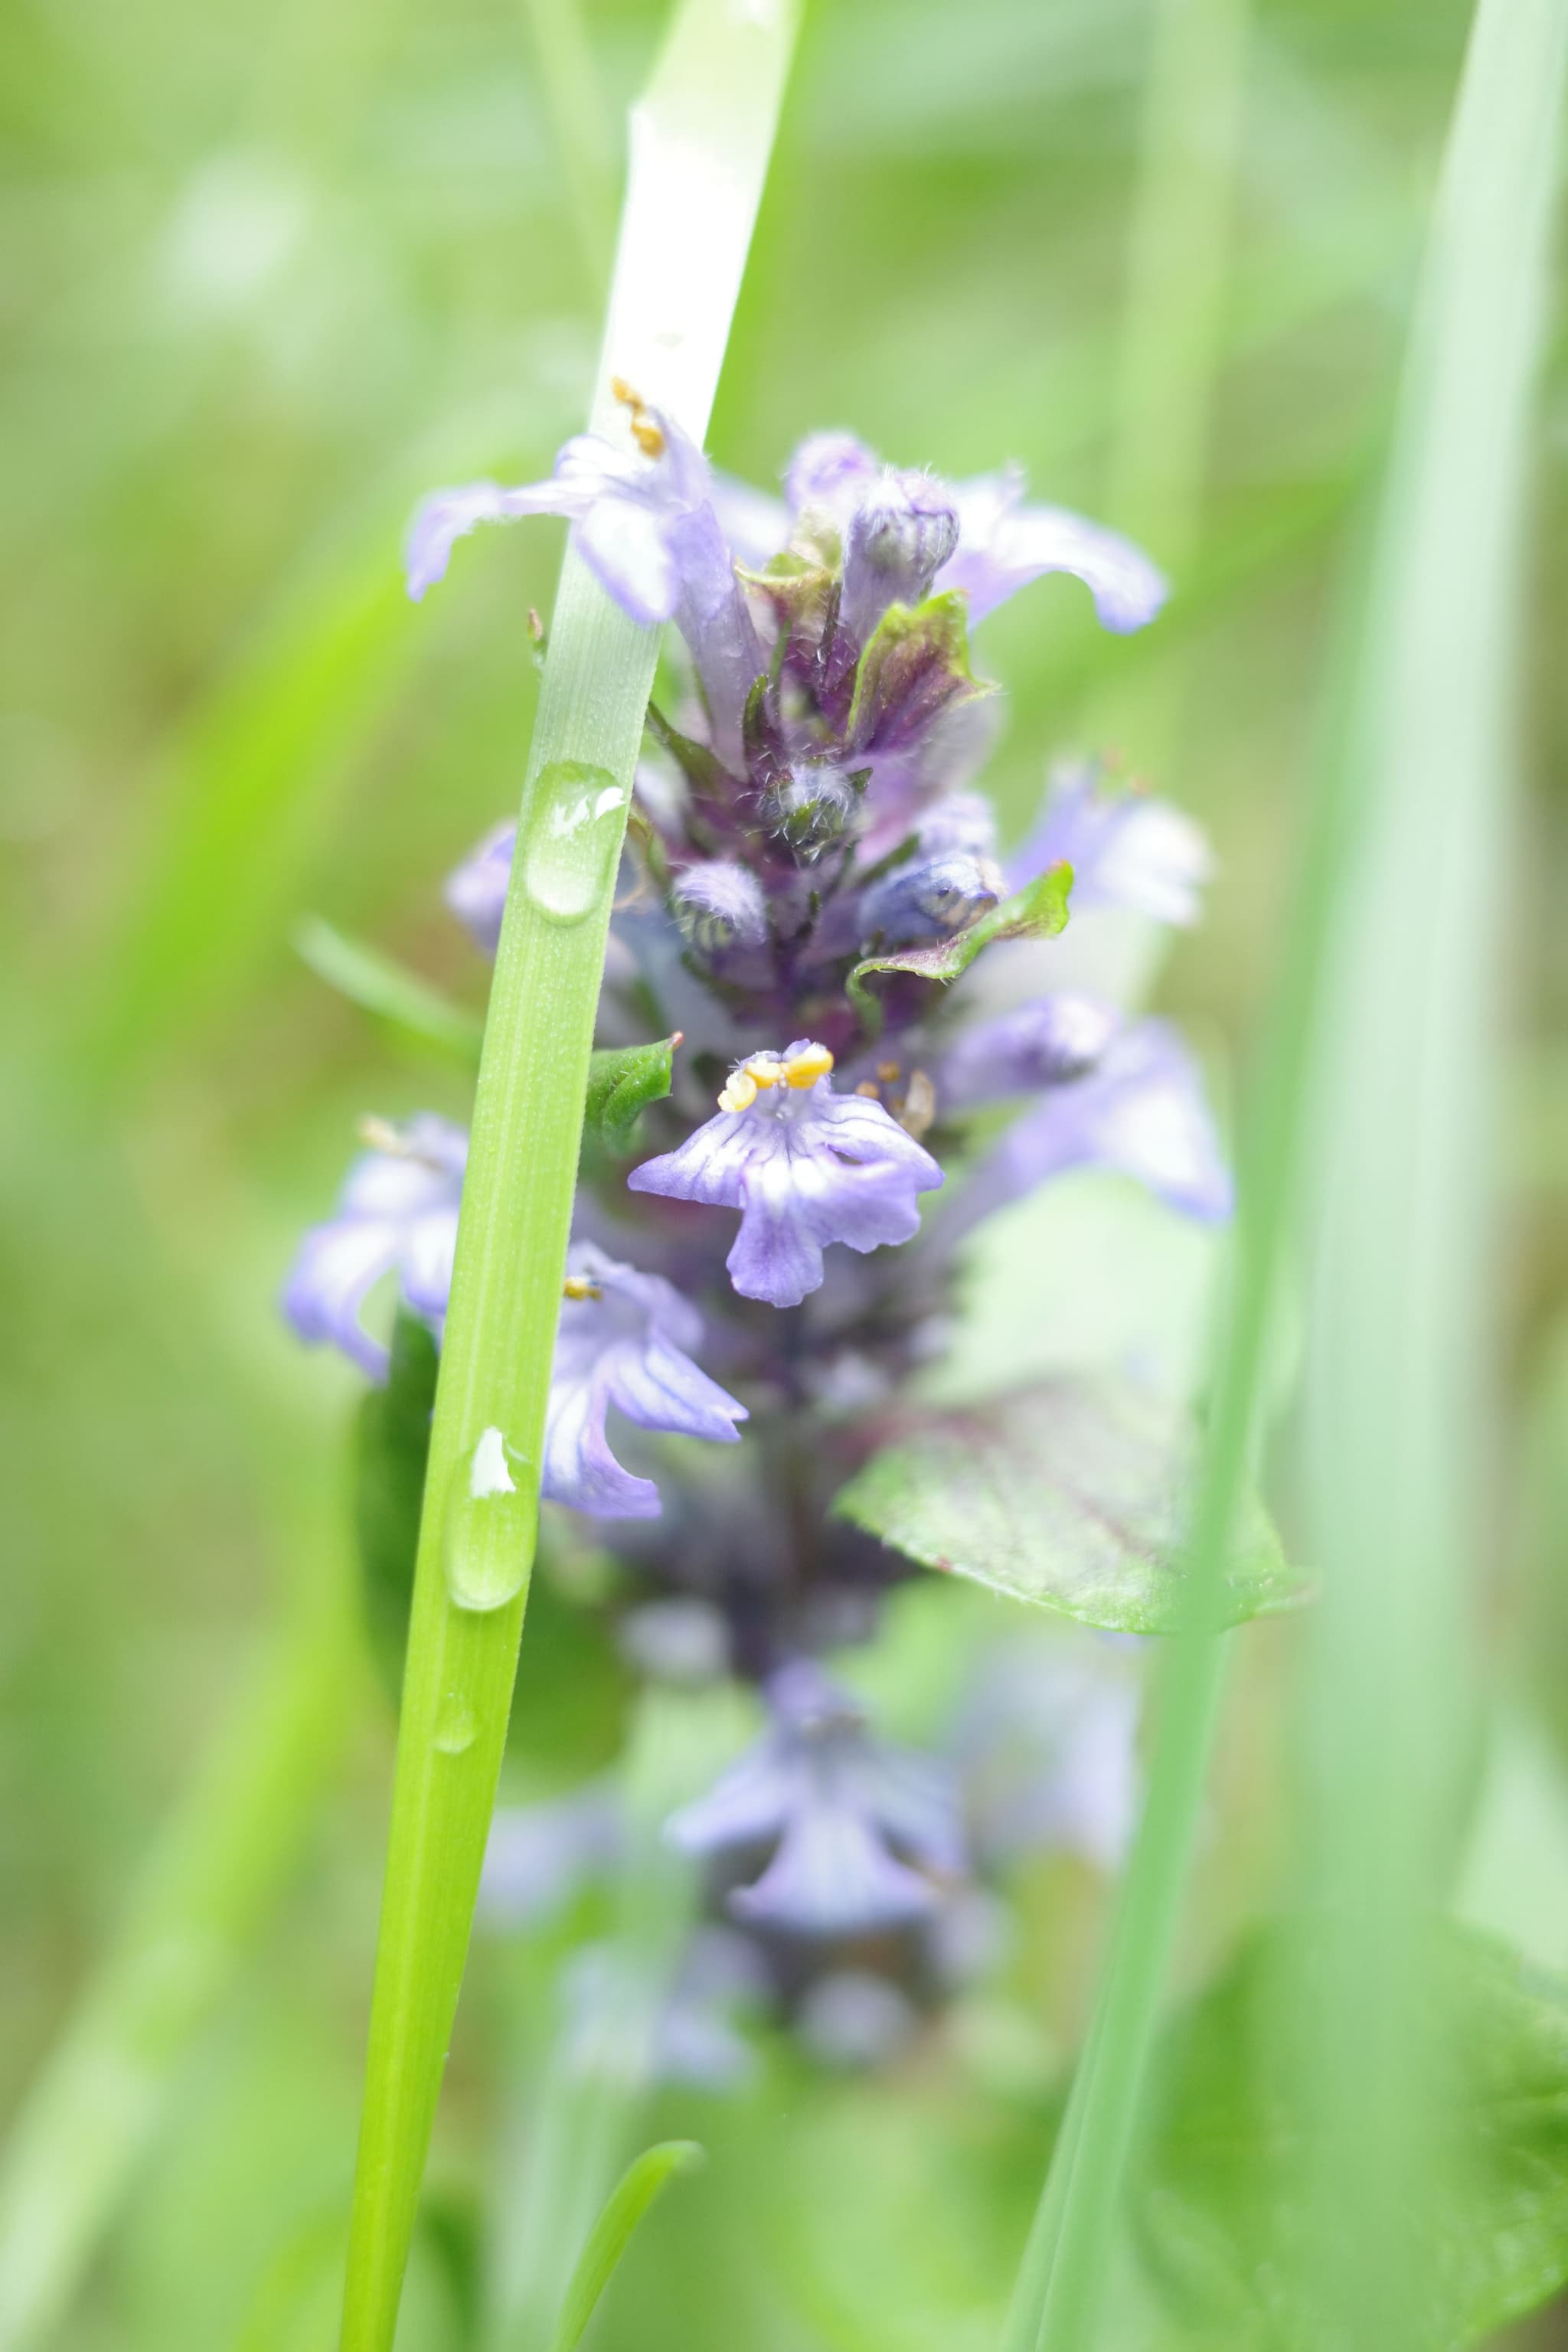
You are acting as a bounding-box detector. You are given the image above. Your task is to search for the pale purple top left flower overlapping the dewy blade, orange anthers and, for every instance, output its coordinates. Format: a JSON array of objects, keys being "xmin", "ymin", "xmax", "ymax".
[{"xmin": 407, "ymin": 386, "xmax": 764, "ymax": 757}]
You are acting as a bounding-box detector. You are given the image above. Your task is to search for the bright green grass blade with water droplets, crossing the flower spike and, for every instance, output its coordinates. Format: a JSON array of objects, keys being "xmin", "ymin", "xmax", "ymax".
[{"xmin": 331, "ymin": 0, "xmax": 795, "ymax": 2352}]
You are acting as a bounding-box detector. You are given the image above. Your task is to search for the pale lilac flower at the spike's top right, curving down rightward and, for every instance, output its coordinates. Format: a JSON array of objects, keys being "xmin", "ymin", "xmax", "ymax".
[{"xmin": 936, "ymin": 466, "xmax": 1168, "ymax": 635}]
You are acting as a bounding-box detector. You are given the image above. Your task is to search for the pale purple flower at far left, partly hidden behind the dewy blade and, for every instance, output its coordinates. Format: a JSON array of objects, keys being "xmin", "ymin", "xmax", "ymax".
[{"xmin": 282, "ymin": 1110, "xmax": 468, "ymax": 1380}]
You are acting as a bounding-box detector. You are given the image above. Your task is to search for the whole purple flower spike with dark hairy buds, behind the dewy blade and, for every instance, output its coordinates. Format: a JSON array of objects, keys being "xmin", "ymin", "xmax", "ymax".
[{"xmin": 285, "ymin": 390, "xmax": 1230, "ymax": 2060}]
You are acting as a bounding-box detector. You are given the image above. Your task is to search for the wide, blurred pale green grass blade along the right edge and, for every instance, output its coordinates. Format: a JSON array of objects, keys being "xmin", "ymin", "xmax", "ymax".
[{"xmin": 1295, "ymin": 0, "xmax": 1568, "ymax": 2352}]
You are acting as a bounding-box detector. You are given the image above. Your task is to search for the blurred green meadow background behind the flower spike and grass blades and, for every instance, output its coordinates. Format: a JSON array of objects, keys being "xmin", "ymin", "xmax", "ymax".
[{"xmin": 0, "ymin": 0, "xmax": 1568, "ymax": 2352}]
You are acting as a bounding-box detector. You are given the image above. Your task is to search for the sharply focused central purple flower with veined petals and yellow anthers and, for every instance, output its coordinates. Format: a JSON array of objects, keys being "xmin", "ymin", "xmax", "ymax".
[{"xmin": 628, "ymin": 1037, "xmax": 942, "ymax": 1308}]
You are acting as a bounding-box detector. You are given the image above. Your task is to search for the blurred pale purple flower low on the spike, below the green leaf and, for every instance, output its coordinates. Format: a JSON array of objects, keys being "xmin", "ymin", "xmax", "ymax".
[{"xmin": 668, "ymin": 1658, "xmax": 964, "ymax": 1936}]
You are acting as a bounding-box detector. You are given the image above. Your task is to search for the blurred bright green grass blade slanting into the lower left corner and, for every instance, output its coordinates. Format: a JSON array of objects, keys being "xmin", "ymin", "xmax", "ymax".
[{"xmin": 0, "ymin": 1573, "xmax": 364, "ymax": 2352}]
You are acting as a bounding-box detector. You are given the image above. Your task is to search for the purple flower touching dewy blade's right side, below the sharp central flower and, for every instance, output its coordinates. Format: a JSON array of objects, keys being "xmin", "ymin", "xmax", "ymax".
[{"xmin": 541, "ymin": 1242, "xmax": 747, "ymax": 1520}]
